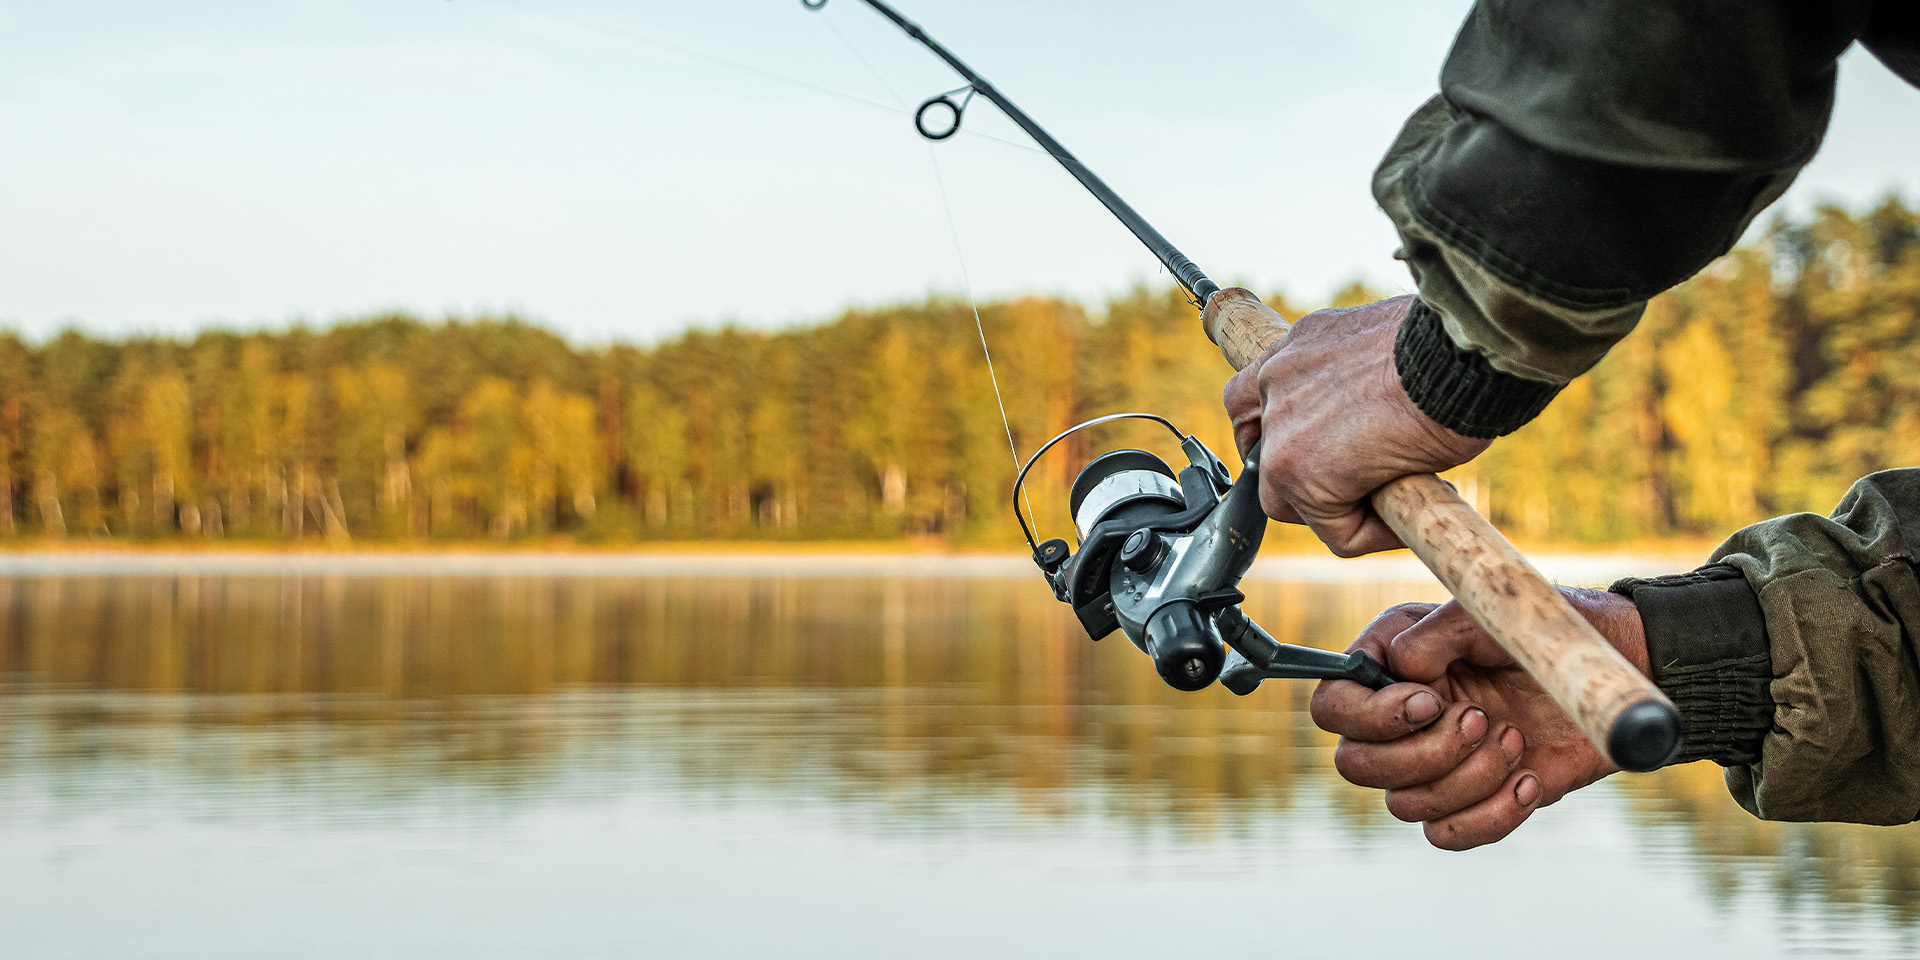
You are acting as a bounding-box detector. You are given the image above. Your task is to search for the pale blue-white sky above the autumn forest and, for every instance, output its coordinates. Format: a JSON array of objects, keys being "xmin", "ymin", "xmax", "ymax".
[{"xmin": 0, "ymin": 0, "xmax": 1920, "ymax": 342}]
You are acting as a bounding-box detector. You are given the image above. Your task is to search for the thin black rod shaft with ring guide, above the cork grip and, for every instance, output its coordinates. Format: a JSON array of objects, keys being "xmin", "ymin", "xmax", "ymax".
[{"xmin": 801, "ymin": 0, "xmax": 1219, "ymax": 309}]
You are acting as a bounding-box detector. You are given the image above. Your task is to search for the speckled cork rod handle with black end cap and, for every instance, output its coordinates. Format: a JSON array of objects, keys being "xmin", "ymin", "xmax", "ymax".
[{"xmin": 1200, "ymin": 286, "xmax": 1680, "ymax": 772}]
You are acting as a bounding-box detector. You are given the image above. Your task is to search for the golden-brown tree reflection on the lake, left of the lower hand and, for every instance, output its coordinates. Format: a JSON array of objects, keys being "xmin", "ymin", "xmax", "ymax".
[{"xmin": 0, "ymin": 576, "xmax": 1413, "ymax": 833}]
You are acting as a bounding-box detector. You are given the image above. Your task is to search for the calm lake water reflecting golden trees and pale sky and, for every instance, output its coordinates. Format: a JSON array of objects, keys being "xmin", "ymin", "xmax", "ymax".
[{"xmin": 0, "ymin": 557, "xmax": 1920, "ymax": 960}]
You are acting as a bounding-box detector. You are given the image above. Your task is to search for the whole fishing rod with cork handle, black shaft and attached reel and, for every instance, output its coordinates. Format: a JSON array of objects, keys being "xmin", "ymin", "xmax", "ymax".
[{"xmin": 801, "ymin": 0, "xmax": 1680, "ymax": 770}]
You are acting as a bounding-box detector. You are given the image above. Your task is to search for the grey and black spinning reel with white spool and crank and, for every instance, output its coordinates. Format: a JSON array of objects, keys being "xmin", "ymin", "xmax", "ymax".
[{"xmin": 1014, "ymin": 413, "xmax": 1394, "ymax": 697}]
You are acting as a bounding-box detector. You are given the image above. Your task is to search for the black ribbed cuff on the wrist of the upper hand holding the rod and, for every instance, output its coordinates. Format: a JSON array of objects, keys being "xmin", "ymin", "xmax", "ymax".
[{"xmin": 1394, "ymin": 300, "xmax": 1567, "ymax": 440}]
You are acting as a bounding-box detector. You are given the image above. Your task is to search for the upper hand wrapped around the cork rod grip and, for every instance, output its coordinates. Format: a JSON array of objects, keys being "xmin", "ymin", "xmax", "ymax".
[{"xmin": 1227, "ymin": 296, "xmax": 1488, "ymax": 557}]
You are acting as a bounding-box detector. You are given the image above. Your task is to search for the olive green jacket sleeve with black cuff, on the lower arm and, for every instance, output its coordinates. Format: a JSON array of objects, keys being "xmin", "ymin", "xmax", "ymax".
[{"xmin": 1615, "ymin": 470, "xmax": 1920, "ymax": 824}]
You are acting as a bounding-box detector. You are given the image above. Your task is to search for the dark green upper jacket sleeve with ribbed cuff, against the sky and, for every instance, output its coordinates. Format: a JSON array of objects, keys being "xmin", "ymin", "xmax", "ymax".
[{"xmin": 1373, "ymin": 0, "xmax": 1874, "ymax": 438}]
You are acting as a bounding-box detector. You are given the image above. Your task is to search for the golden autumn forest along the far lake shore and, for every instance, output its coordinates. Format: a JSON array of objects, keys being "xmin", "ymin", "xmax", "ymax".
[{"xmin": 0, "ymin": 200, "xmax": 1920, "ymax": 545}]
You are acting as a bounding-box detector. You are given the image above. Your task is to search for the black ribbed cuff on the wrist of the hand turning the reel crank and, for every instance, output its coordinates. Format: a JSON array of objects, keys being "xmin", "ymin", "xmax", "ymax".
[{"xmin": 1609, "ymin": 564, "xmax": 1774, "ymax": 766}]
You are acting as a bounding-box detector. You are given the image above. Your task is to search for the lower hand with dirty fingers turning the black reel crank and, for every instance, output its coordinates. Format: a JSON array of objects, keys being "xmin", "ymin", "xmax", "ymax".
[{"xmin": 1313, "ymin": 588, "xmax": 1647, "ymax": 851}]
